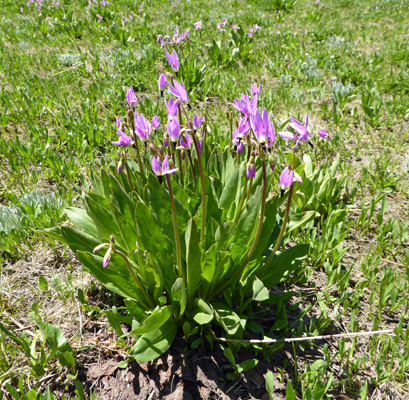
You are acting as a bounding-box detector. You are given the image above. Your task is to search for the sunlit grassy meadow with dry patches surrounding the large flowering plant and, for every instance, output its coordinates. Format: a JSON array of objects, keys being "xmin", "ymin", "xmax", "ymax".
[{"xmin": 0, "ymin": 0, "xmax": 409, "ymax": 399}]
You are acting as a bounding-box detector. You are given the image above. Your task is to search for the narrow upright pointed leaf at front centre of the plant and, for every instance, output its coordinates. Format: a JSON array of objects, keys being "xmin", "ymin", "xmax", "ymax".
[{"xmin": 186, "ymin": 218, "xmax": 202, "ymax": 304}]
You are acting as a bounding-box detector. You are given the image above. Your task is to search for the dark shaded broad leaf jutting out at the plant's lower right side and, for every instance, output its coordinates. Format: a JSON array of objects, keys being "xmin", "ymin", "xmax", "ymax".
[{"xmin": 260, "ymin": 244, "xmax": 309, "ymax": 288}]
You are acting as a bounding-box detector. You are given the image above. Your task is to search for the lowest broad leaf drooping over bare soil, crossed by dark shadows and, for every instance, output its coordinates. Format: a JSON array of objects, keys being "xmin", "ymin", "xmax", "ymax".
[{"xmin": 129, "ymin": 320, "xmax": 177, "ymax": 363}]
